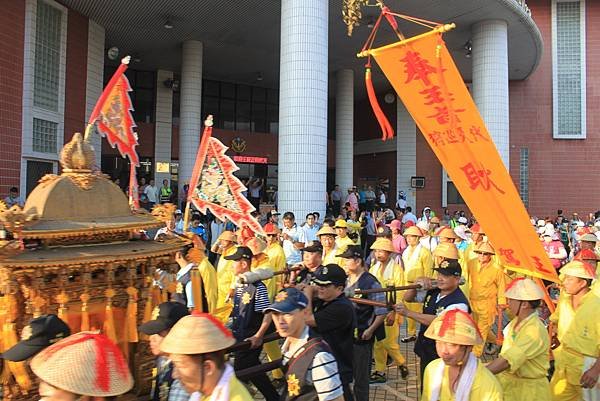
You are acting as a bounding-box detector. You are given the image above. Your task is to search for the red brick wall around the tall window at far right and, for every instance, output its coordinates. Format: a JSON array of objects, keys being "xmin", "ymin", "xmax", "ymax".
[{"xmin": 510, "ymin": 0, "xmax": 600, "ymax": 216}]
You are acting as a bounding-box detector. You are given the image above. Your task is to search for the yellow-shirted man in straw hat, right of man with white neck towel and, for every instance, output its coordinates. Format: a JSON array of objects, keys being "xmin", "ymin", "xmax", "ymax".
[{"xmin": 487, "ymin": 278, "xmax": 551, "ymax": 401}]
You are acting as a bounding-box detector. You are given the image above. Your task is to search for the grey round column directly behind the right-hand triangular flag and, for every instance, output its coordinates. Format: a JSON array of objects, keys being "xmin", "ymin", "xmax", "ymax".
[{"xmin": 178, "ymin": 40, "xmax": 203, "ymax": 193}]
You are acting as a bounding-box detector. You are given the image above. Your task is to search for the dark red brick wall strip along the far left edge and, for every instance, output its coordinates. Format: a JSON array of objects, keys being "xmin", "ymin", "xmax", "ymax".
[{"xmin": 0, "ymin": 0, "xmax": 25, "ymax": 199}]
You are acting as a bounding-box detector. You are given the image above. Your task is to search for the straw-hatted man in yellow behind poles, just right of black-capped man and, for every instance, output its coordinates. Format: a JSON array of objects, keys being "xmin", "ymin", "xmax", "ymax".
[{"xmin": 368, "ymin": 238, "xmax": 408, "ymax": 383}]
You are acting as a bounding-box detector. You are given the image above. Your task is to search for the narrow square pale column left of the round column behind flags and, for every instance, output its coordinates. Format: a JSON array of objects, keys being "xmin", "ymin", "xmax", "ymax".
[{"xmin": 154, "ymin": 70, "xmax": 173, "ymax": 186}]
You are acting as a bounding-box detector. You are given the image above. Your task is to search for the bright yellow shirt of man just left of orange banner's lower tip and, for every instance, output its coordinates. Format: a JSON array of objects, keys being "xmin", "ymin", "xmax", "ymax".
[{"xmin": 469, "ymin": 260, "xmax": 506, "ymax": 314}]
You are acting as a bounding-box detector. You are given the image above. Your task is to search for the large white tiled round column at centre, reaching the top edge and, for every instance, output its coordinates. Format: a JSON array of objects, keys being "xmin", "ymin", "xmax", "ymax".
[{"xmin": 278, "ymin": 0, "xmax": 329, "ymax": 221}]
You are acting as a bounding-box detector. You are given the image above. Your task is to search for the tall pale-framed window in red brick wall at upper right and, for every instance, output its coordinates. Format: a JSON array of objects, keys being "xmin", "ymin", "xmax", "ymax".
[{"xmin": 552, "ymin": 0, "xmax": 586, "ymax": 139}]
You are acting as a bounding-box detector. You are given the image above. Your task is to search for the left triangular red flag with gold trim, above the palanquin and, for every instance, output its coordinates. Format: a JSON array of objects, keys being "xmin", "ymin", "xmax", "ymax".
[{"xmin": 88, "ymin": 57, "xmax": 140, "ymax": 166}]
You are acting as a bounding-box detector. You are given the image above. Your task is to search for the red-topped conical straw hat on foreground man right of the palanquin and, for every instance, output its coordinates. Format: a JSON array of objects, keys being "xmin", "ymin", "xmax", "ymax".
[{"xmin": 160, "ymin": 312, "xmax": 235, "ymax": 355}]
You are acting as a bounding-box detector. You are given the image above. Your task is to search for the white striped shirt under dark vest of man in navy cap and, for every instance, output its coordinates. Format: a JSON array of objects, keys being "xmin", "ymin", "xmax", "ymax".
[{"xmin": 281, "ymin": 326, "xmax": 344, "ymax": 401}]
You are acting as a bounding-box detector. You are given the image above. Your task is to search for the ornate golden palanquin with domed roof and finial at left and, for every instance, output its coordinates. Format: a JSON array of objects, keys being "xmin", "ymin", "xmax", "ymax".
[{"xmin": 0, "ymin": 134, "xmax": 189, "ymax": 399}]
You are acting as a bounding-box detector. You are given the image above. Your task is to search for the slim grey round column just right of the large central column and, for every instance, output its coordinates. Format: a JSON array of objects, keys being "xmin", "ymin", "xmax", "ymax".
[{"xmin": 335, "ymin": 70, "xmax": 354, "ymax": 191}]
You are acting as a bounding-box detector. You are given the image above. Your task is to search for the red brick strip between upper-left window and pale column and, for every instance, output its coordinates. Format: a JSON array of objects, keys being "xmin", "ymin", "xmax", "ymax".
[{"xmin": 65, "ymin": 10, "xmax": 88, "ymax": 143}]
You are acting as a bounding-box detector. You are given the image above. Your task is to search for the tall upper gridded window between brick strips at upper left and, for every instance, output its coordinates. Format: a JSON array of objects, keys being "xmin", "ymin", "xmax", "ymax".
[{"xmin": 33, "ymin": 0, "xmax": 62, "ymax": 112}]
